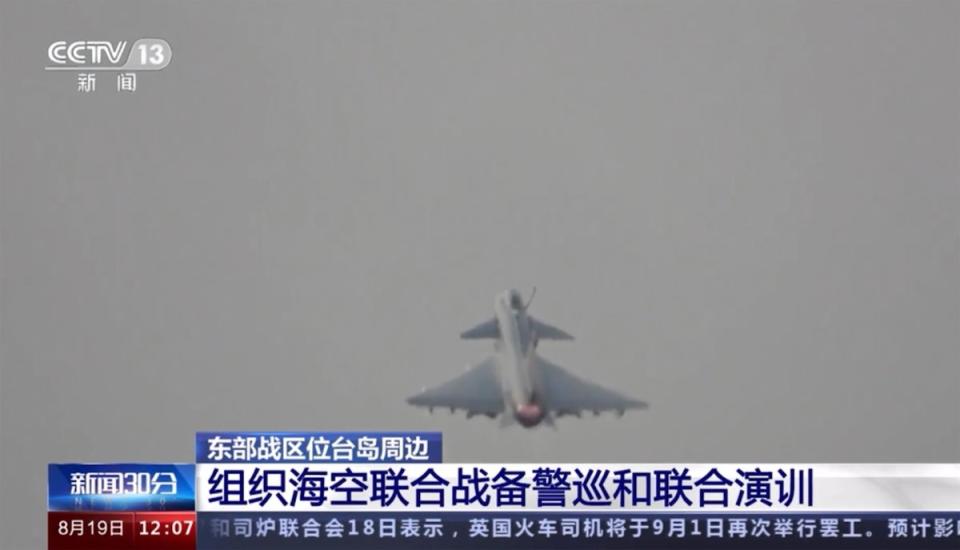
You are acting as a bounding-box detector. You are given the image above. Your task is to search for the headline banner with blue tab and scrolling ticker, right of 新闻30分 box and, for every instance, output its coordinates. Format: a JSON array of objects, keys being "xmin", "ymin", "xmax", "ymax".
[{"xmin": 189, "ymin": 432, "xmax": 960, "ymax": 550}]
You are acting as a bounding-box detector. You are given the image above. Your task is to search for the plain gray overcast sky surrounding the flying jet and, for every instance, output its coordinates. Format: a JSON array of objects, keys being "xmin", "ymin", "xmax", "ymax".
[{"xmin": 0, "ymin": 1, "xmax": 960, "ymax": 550}]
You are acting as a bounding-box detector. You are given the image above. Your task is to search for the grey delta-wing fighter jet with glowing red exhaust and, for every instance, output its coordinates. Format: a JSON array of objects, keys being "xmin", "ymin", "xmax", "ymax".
[{"xmin": 407, "ymin": 289, "xmax": 647, "ymax": 428}]
